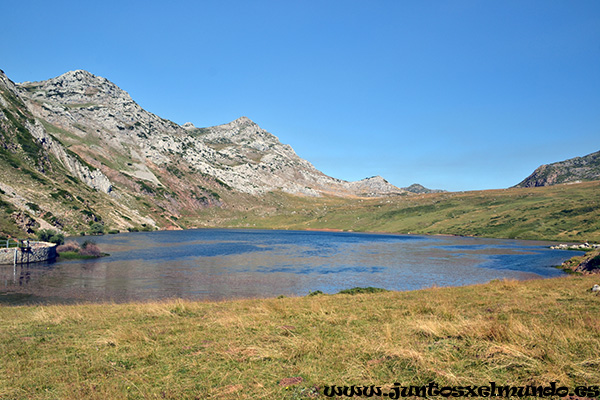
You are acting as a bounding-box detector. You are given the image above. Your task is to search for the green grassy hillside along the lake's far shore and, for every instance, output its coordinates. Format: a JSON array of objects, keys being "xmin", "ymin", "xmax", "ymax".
[{"xmin": 198, "ymin": 181, "xmax": 600, "ymax": 242}]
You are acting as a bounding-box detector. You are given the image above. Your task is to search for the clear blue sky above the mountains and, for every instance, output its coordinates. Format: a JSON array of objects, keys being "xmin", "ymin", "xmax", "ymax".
[{"xmin": 0, "ymin": 0, "xmax": 600, "ymax": 190}]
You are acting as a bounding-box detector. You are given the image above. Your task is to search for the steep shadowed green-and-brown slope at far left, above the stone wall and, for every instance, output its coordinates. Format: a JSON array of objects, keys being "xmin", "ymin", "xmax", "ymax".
[{"xmin": 0, "ymin": 71, "xmax": 151, "ymax": 236}]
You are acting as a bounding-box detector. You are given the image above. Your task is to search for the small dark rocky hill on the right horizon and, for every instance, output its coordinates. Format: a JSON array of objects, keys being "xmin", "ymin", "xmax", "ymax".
[{"xmin": 514, "ymin": 151, "xmax": 600, "ymax": 187}]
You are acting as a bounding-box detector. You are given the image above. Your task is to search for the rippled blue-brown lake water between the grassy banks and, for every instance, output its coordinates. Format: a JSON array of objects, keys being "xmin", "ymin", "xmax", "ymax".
[{"xmin": 0, "ymin": 229, "xmax": 576, "ymax": 304}]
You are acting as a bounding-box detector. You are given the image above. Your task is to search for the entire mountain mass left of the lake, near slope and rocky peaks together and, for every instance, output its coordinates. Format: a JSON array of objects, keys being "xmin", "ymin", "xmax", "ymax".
[{"xmin": 0, "ymin": 70, "xmax": 408, "ymax": 235}]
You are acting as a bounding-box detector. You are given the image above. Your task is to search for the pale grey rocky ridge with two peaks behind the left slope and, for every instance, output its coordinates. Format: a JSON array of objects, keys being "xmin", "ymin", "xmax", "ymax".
[{"xmin": 19, "ymin": 71, "xmax": 410, "ymax": 196}]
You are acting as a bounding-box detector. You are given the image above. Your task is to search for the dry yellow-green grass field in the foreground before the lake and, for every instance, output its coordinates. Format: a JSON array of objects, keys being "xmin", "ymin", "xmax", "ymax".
[{"xmin": 0, "ymin": 276, "xmax": 600, "ymax": 399}]
